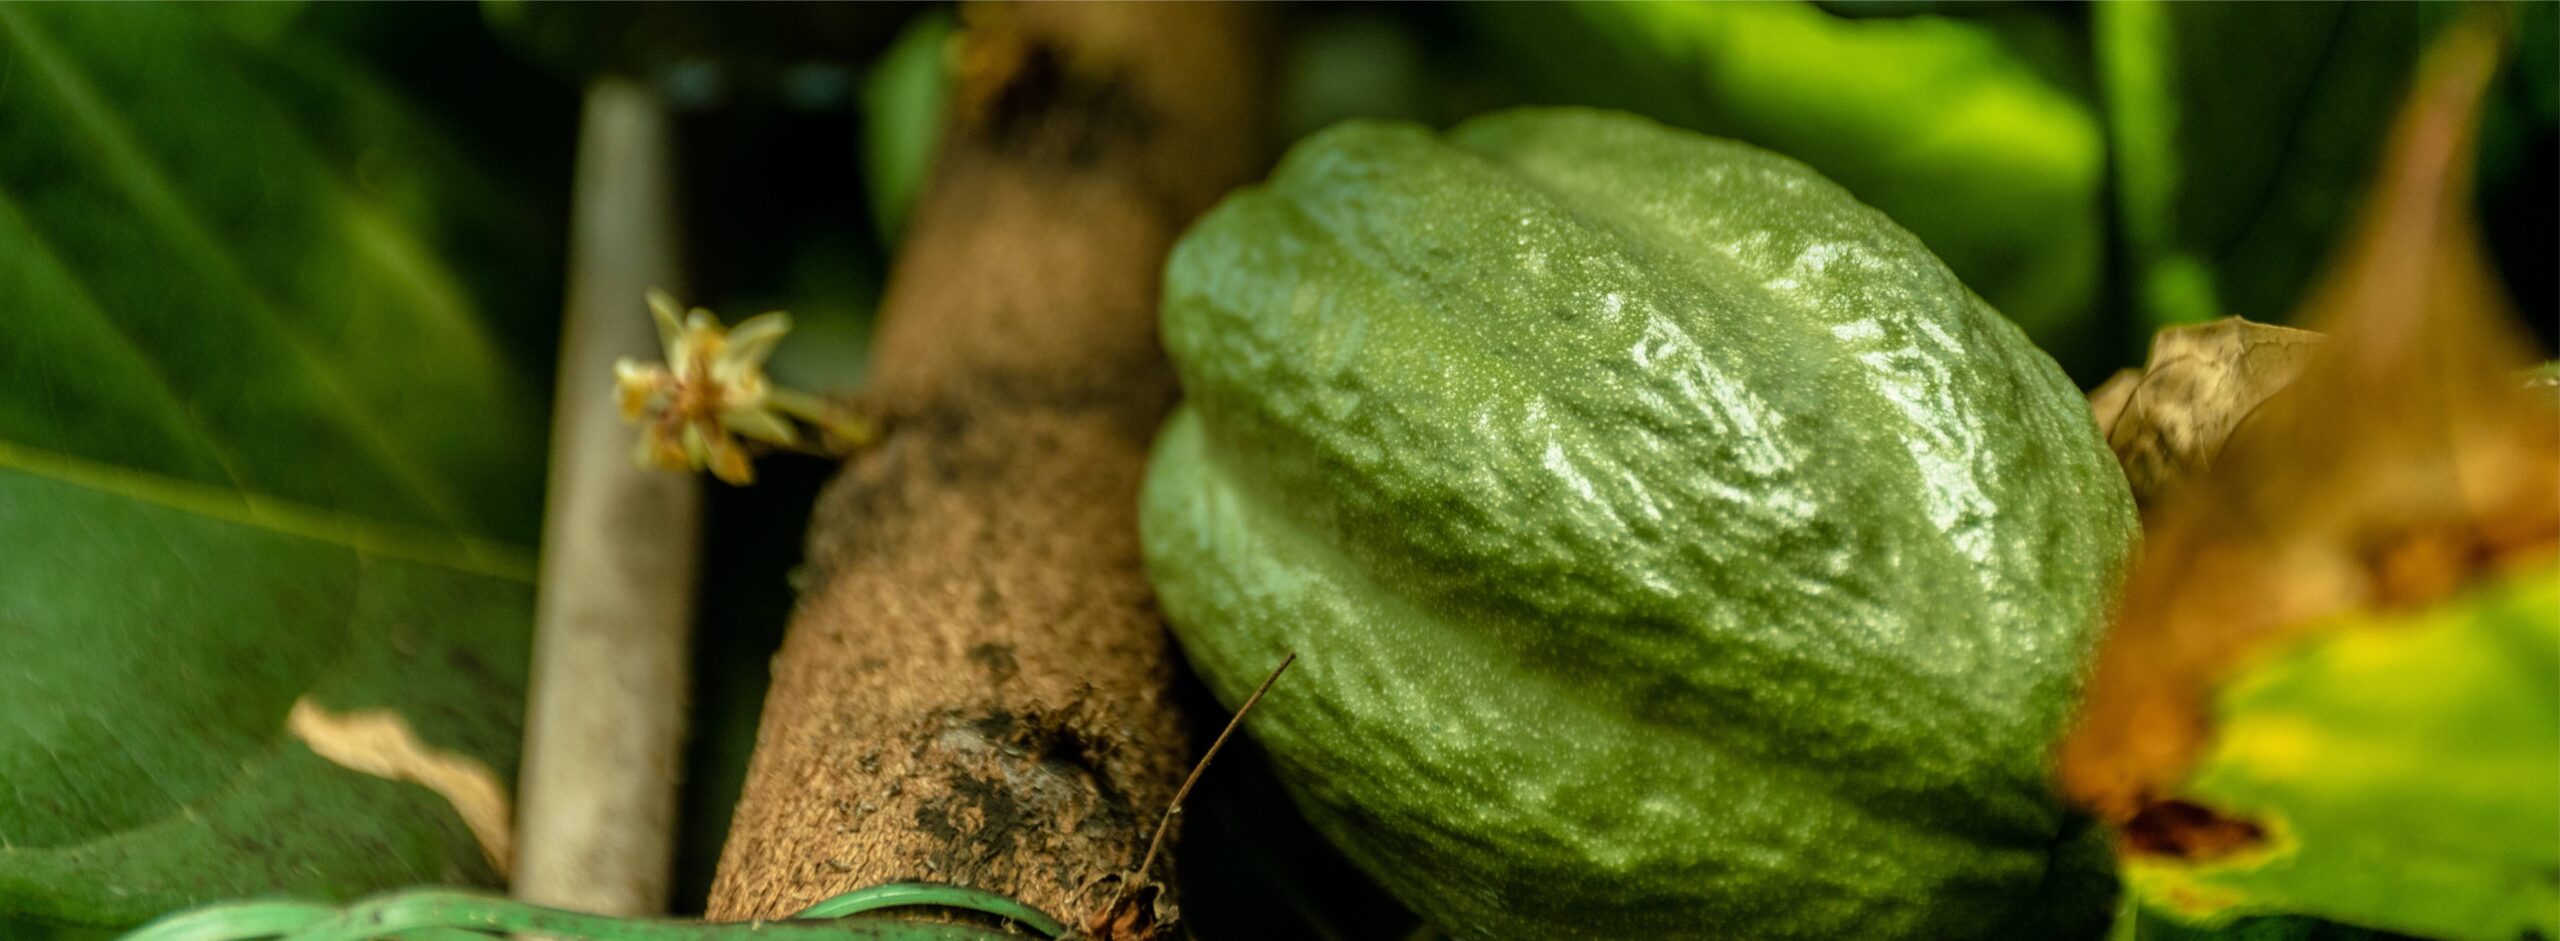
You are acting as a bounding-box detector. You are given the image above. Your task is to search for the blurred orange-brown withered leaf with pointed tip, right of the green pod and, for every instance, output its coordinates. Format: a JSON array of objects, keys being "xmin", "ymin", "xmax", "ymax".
[{"xmin": 2061, "ymin": 18, "xmax": 2560, "ymax": 823}]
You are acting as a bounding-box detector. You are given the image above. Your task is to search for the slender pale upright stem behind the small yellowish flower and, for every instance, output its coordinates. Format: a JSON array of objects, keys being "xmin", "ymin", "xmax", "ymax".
[{"xmin": 515, "ymin": 79, "xmax": 701, "ymax": 915}]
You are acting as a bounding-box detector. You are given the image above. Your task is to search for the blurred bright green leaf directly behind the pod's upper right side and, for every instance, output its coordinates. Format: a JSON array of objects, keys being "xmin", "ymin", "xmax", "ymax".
[{"xmin": 1467, "ymin": 3, "xmax": 2107, "ymax": 363}]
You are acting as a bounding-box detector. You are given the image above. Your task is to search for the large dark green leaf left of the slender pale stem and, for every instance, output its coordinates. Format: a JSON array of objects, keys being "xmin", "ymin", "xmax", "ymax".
[{"xmin": 0, "ymin": 5, "xmax": 553, "ymax": 926}]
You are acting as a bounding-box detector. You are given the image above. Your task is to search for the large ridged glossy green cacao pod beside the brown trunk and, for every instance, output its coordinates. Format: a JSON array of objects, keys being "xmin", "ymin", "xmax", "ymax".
[{"xmin": 1142, "ymin": 110, "xmax": 2135, "ymax": 938}]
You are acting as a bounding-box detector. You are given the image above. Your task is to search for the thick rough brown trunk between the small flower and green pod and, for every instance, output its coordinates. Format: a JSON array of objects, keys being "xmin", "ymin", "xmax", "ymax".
[{"xmin": 709, "ymin": 5, "xmax": 1262, "ymax": 935}]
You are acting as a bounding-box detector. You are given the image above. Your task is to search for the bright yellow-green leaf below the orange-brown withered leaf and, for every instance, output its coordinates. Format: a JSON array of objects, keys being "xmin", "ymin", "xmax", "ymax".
[{"xmin": 2125, "ymin": 560, "xmax": 2560, "ymax": 941}]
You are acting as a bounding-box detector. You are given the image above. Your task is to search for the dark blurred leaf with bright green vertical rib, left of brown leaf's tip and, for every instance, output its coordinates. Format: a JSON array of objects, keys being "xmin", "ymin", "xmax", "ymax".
[{"xmin": 2094, "ymin": 0, "xmax": 2460, "ymax": 327}]
